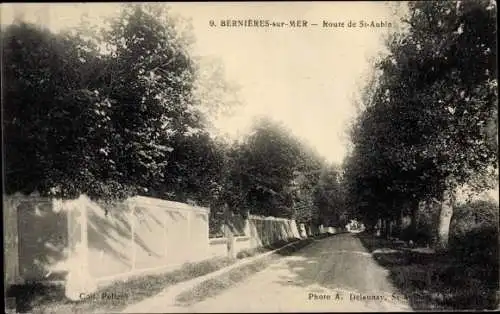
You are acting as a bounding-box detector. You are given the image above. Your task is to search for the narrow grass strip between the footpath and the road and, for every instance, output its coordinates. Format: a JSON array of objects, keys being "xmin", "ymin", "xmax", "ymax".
[{"xmin": 176, "ymin": 234, "xmax": 322, "ymax": 306}]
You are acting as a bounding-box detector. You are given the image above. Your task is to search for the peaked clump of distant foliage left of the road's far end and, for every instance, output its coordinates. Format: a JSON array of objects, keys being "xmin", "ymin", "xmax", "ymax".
[{"xmin": 217, "ymin": 118, "xmax": 342, "ymax": 224}]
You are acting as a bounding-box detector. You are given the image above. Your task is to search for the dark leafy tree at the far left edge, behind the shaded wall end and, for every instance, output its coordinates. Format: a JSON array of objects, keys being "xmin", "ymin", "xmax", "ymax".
[{"xmin": 2, "ymin": 23, "xmax": 124, "ymax": 196}]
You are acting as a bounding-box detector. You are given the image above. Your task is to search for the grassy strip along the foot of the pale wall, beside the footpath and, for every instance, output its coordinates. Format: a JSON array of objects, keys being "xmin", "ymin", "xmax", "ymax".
[{"xmin": 7, "ymin": 258, "xmax": 236, "ymax": 313}]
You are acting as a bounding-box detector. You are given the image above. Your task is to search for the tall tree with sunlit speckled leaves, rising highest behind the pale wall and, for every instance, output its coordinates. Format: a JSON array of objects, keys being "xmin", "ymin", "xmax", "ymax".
[{"xmin": 96, "ymin": 5, "xmax": 200, "ymax": 192}]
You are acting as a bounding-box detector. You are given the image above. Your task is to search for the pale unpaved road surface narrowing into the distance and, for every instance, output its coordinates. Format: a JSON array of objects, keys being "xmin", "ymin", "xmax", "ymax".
[{"xmin": 170, "ymin": 234, "xmax": 411, "ymax": 313}]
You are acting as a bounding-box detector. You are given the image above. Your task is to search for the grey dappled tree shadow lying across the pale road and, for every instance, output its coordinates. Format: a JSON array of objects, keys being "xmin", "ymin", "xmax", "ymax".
[{"xmin": 271, "ymin": 234, "xmax": 402, "ymax": 295}]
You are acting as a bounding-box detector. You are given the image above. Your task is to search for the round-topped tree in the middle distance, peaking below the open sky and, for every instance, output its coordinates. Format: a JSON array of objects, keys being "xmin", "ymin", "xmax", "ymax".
[{"xmin": 225, "ymin": 118, "xmax": 300, "ymax": 217}]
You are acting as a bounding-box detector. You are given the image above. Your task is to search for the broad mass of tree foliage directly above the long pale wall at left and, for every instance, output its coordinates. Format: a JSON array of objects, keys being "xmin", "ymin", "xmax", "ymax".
[{"xmin": 2, "ymin": 5, "xmax": 222, "ymax": 198}]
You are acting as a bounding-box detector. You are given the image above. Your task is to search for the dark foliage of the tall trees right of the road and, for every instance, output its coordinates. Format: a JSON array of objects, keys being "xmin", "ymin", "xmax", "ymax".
[{"xmin": 346, "ymin": 1, "xmax": 498, "ymax": 226}]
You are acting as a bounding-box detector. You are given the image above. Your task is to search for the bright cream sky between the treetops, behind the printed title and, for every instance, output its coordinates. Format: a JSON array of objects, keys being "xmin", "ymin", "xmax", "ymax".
[{"xmin": 2, "ymin": 2, "xmax": 404, "ymax": 162}]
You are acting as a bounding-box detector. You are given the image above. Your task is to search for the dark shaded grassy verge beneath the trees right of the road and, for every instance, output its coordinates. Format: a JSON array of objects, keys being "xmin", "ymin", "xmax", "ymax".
[{"xmin": 359, "ymin": 235, "xmax": 498, "ymax": 311}]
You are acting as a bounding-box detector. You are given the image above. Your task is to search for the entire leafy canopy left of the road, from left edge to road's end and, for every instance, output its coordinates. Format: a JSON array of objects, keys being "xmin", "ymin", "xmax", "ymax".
[{"xmin": 2, "ymin": 4, "xmax": 340, "ymax": 228}]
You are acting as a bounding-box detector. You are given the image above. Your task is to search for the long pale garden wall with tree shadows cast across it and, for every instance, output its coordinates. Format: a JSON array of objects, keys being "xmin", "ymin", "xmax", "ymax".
[{"xmin": 4, "ymin": 195, "xmax": 210, "ymax": 284}]
